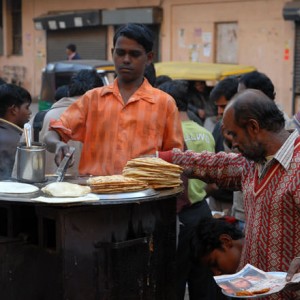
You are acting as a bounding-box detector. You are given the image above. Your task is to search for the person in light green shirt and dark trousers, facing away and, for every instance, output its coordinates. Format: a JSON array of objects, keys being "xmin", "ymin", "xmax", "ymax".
[{"xmin": 159, "ymin": 80, "xmax": 224, "ymax": 300}]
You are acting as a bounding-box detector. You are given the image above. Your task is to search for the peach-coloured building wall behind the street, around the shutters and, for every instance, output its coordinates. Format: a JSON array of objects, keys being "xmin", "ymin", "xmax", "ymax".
[{"xmin": 0, "ymin": 0, "xmax": 295, "ymax": 115}]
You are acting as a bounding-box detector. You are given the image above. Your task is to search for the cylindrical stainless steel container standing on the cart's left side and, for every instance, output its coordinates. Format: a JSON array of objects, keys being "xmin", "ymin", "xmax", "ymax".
[{"xmin": 17, "ymin": 142, "xmax": 46, "ymax": 183}]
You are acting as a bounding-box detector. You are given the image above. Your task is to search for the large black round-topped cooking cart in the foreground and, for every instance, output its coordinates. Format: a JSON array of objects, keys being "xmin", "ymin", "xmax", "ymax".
[{"xmin": 0, "ymin": 183, "xmax": 182, "ymax": 300}]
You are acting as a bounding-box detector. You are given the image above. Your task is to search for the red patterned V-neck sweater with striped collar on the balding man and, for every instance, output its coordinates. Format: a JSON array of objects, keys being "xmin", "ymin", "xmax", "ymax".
[{"xmin": 159, "ymin": 130, "xmax": 300, "ymax": 299}]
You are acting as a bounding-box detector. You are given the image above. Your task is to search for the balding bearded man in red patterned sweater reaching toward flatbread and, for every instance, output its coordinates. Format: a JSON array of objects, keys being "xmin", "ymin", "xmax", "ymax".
[{"xmin": 159, "ymin": 89, "xmax": 300, "ymax": 300}]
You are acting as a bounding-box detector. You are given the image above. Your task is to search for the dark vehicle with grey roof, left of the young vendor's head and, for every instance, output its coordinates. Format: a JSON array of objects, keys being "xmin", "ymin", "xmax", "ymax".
[{"xmin": 38, "ymin": 59, "xmax": 115, "ymax": 110}]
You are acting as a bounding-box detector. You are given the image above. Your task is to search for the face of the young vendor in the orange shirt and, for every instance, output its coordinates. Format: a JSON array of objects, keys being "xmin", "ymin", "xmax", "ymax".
[{"xmin": 112, "ymin": 36, "xmax": 153, "ymax": 83}]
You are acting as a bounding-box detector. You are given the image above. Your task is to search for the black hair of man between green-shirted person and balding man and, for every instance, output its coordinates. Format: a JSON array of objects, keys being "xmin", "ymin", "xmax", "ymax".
[{"xmin": 209, "ymin": 76, "xmax": 239, "ymax": 102}]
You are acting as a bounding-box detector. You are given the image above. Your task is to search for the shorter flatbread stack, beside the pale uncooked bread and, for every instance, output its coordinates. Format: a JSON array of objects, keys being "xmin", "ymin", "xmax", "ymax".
[{"xmin": 87, "ymin": 175, "xmax": 148, "ymax": 194}]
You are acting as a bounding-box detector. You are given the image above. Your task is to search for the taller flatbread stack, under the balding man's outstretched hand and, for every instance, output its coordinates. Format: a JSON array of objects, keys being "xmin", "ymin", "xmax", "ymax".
[{"xmin": 123, "ymin": 157, "xmax": 183, "ymax": 189}]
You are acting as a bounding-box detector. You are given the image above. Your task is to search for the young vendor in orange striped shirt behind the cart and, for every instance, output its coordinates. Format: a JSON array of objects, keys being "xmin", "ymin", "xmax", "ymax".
[{"xmin": 45, "ymin": 24, "xmax": 183, "ymax": 175}]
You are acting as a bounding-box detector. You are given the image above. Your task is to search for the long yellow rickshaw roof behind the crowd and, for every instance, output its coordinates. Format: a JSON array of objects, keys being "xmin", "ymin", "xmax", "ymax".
[{"xmin": 155, "ymin": 61, "xmax": 256, "ymax": 81}]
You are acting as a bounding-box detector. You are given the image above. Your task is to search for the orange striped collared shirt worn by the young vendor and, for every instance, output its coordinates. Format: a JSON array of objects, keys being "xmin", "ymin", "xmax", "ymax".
[{"xmin": 50, "ymin": 79, "xmax": 183, "ymax": 175}]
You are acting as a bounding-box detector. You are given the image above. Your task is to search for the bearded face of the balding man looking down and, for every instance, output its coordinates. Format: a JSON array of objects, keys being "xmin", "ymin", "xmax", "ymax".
[{"xmin": 222, "ymin": 108, "xmax": 266, "ymax": 162}]
